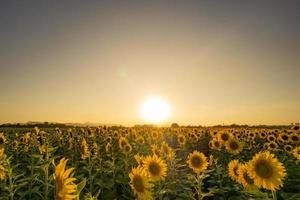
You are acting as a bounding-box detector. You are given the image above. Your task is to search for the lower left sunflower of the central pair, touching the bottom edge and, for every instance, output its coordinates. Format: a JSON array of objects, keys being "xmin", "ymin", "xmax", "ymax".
[{"xmin": 129, "ymin": 167, "xmax": 153, "ymax": 200}]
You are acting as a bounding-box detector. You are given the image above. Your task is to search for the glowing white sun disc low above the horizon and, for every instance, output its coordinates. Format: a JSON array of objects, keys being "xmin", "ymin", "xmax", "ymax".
[{"xmin": 141, "ymin": 97, "xmax": 171, "ymax": 123}]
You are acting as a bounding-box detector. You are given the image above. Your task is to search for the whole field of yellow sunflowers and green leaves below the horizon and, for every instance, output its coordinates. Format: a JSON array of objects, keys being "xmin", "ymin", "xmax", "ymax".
[{"xmin": 0, "ymin": 126, "xmax": 300, "ymax": 200}]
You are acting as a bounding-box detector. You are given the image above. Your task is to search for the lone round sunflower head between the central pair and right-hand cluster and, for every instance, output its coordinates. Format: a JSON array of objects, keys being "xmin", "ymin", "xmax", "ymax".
[{"xmin": 187, "ymin": 151, "xmax": 208, "ymax": 174}]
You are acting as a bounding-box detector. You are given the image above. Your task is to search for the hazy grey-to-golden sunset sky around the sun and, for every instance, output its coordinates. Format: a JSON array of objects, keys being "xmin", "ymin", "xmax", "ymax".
[{"xmin": 0, "ymin": 0, "xmax": 300, "ymax": 125}]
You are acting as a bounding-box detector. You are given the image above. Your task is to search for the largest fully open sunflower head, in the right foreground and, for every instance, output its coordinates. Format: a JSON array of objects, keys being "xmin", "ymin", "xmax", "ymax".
[{"xmin": 248, "ymin": 151, "xmax": 286, "ymax": 191}]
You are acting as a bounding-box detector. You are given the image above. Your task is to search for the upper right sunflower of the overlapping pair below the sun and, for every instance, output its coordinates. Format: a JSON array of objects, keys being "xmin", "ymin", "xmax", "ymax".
[{"xmin": 143, "ymin": 155, "xmax": 167, "ymax": 181}]
